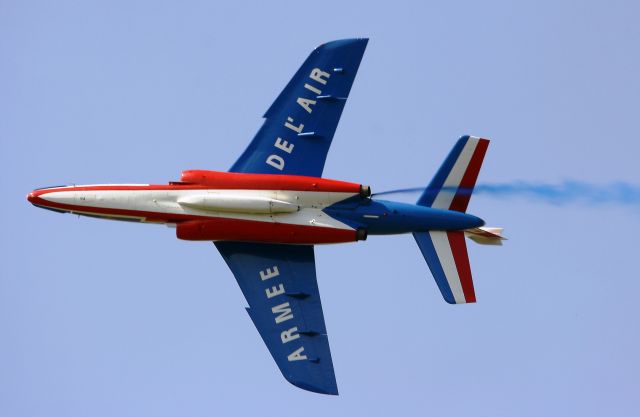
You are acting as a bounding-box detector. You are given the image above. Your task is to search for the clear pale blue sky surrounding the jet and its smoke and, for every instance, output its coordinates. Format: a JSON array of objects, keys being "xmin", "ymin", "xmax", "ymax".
[{"xmin": 0, "ymin": 0, "xmax": 640, "ymax": 417}]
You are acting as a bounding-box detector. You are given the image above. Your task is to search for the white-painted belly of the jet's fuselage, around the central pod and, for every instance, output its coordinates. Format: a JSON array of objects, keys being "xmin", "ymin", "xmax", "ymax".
[{"xmin": 40, "ymin": 188, "xmax": 356, "ymax": 230}]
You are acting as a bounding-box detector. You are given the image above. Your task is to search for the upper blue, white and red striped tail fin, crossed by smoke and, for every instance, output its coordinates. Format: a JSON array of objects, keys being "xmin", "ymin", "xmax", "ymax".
[{"xmin": 417, "ymin": 136, "xmax": 489, "ymax": 212}]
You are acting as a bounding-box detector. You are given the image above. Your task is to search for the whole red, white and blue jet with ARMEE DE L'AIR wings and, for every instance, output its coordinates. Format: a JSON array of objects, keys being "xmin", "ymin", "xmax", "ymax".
[{"xmin": 27, "ymin": 39, "xmax": 502, "ymax": 395}]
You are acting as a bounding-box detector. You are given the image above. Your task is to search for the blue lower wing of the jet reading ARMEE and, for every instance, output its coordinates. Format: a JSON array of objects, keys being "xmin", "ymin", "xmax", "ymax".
[{"xmin": 214, "ymin": 242, "xmax": 338, "ymax": 395}]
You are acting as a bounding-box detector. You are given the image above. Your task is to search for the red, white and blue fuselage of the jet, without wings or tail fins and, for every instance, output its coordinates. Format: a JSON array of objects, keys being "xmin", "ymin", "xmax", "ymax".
[{"xmin": 28, "ymin": 171, "xmax": 484, "ymax": 244}]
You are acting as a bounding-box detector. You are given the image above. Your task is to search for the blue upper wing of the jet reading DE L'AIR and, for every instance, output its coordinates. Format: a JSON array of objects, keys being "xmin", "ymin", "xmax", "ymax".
[{"xmin": 229, "ymin": 39, "xmax": 368, "ymax": 177}]
